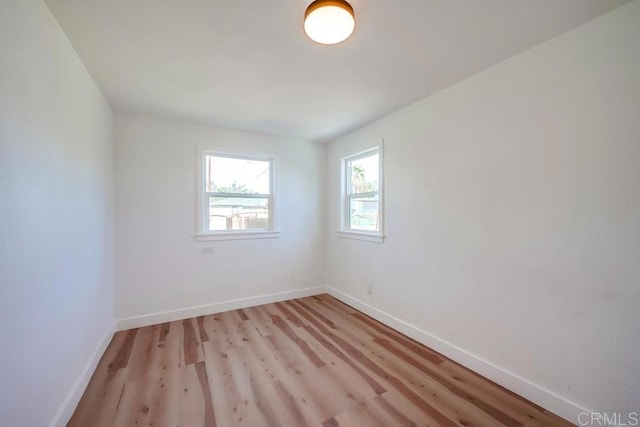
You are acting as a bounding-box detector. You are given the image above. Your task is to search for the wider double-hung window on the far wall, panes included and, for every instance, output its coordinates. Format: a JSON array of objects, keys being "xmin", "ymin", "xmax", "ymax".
[{"xmin": 198, "ymin": 150, "xmax": 276, "ymax": 240}]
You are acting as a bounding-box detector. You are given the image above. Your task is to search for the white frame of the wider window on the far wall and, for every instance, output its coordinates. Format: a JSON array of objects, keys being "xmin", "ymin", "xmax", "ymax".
[{"xmin": 195, "ymin": 147, "xmax": 280, "ymax": 242}]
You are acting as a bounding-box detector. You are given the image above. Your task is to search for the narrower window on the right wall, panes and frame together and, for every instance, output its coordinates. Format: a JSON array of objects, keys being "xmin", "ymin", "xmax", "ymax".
[{"xmin": 340, "ymin": 147, "xmax": 382, "ymax": 242}]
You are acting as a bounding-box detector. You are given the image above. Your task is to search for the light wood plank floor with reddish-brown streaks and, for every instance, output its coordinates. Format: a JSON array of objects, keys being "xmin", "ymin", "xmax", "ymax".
[{"xmin": 69, "ymin": 295, "xmax": 571, "ymax": 427}]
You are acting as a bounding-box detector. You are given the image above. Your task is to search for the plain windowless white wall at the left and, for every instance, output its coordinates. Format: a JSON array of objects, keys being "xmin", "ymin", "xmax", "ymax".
[{"xmin": 0, "ymin": 0, "xmax": 113, "ymax": 427}]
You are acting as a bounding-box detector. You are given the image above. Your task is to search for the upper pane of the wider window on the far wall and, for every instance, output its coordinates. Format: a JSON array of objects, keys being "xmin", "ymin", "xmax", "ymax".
[{"xmin": 205, "ymin": 155, "xmax": 271, "ymax": 194}]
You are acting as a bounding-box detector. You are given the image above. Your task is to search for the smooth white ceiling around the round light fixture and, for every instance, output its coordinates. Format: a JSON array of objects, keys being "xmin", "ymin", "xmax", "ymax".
[{"xmin": 46, "ymin": 0, "xmax": 627, "ymax": 141}]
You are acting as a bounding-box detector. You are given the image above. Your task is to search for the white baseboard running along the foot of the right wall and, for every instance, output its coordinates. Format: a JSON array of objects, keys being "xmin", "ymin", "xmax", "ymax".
[{"xmin": 326, "ymin": 286, "xmax": 590, "ymax": 424}]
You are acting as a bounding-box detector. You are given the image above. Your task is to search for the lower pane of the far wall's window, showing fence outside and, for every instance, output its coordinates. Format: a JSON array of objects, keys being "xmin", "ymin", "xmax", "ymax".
[{"xmin": 209, "ymin": 197, "xmax": 269, "ymax": 231}]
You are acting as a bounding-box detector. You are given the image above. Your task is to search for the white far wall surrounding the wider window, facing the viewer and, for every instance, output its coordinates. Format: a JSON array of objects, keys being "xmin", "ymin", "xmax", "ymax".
[{"xmin": 115, "ymin": 113, "xmax": 326, "ymax": 327}]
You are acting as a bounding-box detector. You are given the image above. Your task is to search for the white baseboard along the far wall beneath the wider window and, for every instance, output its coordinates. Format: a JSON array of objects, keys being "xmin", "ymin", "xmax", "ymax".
[{"xmin": 116, "ymin": 286, "xmax": 327, "ymax": 331}]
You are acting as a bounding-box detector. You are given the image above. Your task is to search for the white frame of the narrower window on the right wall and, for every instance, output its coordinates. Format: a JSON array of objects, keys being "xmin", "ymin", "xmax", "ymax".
[{"xmin": 338, "ymin": 143, "xmax": 385, "ymax": 243}]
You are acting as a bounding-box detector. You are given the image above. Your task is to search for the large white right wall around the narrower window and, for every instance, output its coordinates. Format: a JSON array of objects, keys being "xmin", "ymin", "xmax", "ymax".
[{"xmin": 327, "ymin": 1, "xmax": 640, "ymax": 420}]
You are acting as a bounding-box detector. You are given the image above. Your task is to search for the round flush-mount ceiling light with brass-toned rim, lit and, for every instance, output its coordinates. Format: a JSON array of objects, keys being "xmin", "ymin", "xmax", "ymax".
[{"xmin": 304, "ymin": 0, "xmax": 356, "ymax": 44}]
